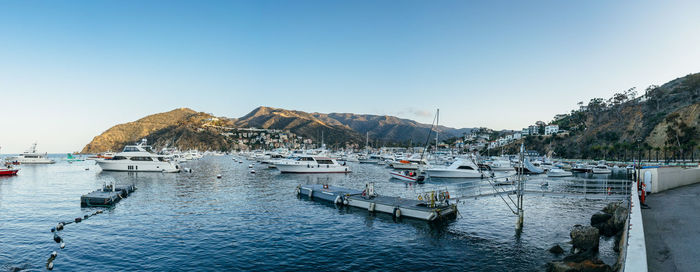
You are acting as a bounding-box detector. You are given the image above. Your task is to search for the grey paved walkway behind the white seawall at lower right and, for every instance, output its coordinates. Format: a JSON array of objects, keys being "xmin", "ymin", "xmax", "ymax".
[{"xmin": 642, "ymin": 181, "xmax": 700, "ymax": 271}]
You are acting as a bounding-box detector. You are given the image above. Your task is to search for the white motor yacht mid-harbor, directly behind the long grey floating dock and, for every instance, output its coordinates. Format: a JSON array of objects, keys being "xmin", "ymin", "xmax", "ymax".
[{"xmin": 275, "ymin": 155, "xmax": 351, "ymax": 173}]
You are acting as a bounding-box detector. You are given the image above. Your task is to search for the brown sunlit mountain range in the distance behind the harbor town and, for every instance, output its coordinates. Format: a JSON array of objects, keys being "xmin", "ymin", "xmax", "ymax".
[{"xmin": 81, "ymin": 106, "xmax": 471, "ymax": 153}]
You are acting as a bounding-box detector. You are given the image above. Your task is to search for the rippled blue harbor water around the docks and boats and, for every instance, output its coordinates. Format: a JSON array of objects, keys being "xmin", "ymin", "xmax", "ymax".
[{"xmin": 0, "ymin": 156, "xmax": 615, "ymax": 271}]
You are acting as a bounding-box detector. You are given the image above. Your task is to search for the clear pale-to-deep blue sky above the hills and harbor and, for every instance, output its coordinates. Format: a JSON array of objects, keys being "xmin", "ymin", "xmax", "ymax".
[{"xmin": 0, "ymin": 0, "xmax": 700, "ymax": 153}]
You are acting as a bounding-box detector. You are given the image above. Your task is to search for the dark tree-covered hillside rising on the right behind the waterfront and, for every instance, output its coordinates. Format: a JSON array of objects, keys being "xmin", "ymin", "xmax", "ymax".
[{"xmin": 507, "ymin": 73, "xmax": 700, "ymax": 159}]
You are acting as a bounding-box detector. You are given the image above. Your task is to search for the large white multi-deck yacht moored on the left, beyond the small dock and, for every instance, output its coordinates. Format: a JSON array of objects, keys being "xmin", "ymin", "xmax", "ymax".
[{"xmin": 95, "ymin": 140, "xmax": 180, "ymax": 173}]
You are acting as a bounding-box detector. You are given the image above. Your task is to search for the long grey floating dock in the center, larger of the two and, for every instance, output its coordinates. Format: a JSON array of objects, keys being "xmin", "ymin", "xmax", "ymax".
[{"xmin": 296, "ymin": 184, "xmax": 457, "ymax": 221}]
